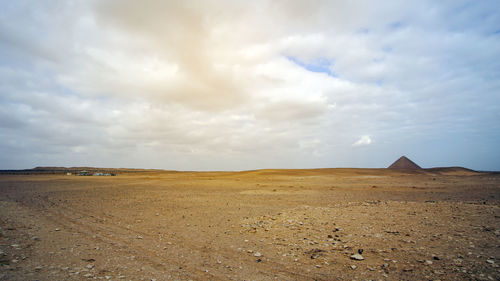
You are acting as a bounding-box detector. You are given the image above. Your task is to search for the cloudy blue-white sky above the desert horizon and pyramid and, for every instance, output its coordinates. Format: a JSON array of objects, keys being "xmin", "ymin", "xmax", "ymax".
[{"xmin": 0, "ymin": 0, "xmax": 500, "ymax": 170}]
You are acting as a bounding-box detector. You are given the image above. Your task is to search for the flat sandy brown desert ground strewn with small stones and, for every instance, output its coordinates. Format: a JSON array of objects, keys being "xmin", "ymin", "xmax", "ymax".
[{"xmin": 0, "ymin": 169, "xmax": 500, "ymax": 280}]
